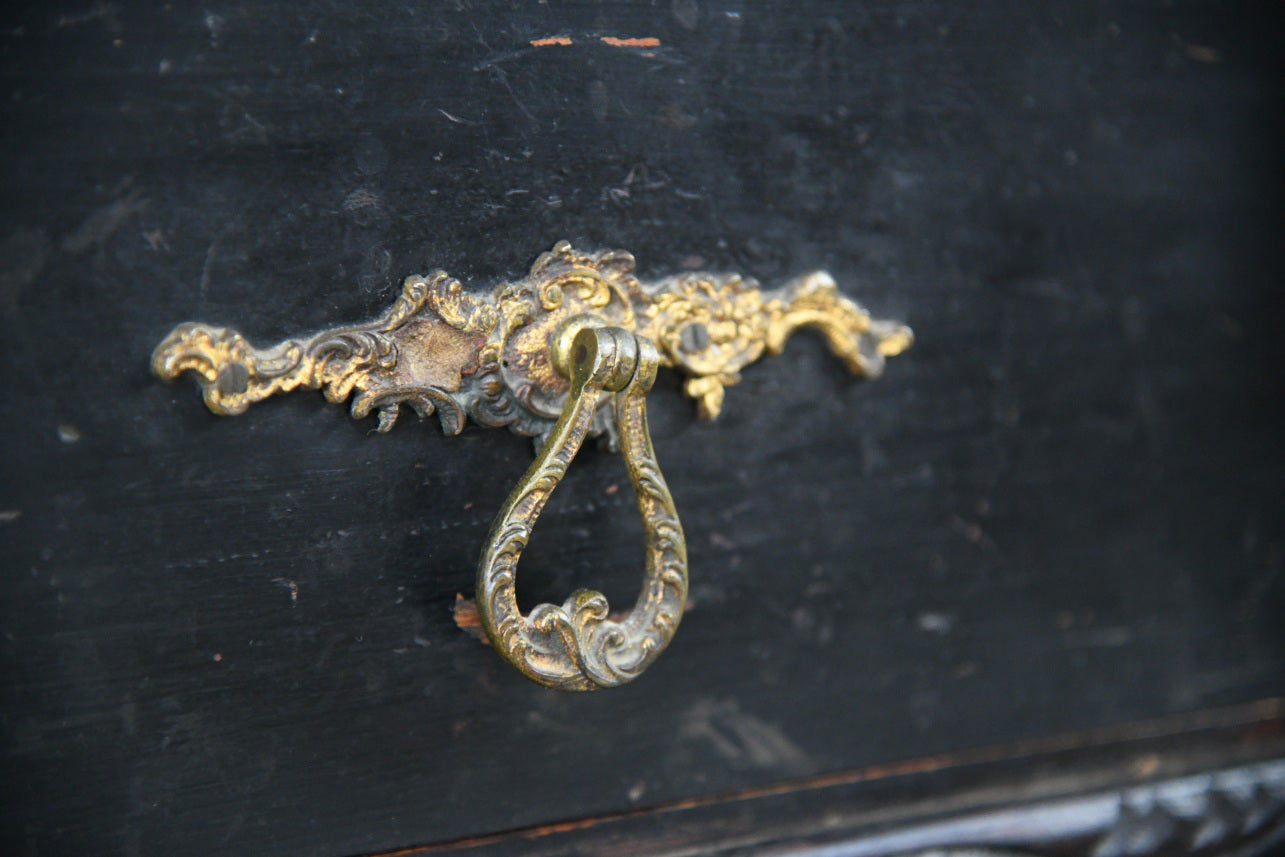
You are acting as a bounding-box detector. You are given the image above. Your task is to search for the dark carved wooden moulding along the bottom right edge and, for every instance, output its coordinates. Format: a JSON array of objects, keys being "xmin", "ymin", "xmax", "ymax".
[{"xmin": 388, "ymin": 704, "xmax": 1285, "ymax": 857}]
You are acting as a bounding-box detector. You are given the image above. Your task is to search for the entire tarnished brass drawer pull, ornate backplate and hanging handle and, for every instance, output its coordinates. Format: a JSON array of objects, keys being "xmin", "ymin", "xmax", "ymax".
[{"xmin": 152, "ymin": 242, "xmax": 912, "ymax": 690}]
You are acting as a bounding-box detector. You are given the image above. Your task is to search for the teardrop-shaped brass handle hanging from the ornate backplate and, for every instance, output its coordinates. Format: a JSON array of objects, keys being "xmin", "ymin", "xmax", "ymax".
[{"xmin": 477, "ymin": 326, "xmax": 687, "ymax": 690}]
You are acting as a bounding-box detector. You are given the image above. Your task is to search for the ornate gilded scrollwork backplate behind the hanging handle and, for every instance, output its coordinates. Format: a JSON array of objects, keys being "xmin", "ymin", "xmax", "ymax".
[{"xmin": 152, "ymin": 242, "xmax": 912, "ymax": 438}]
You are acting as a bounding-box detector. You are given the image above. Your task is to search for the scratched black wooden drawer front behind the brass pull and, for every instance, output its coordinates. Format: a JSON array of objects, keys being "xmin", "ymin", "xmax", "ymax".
[{"xmin": 0, "ymin": 0, "xmax": 1285, "ymax": 854}]
